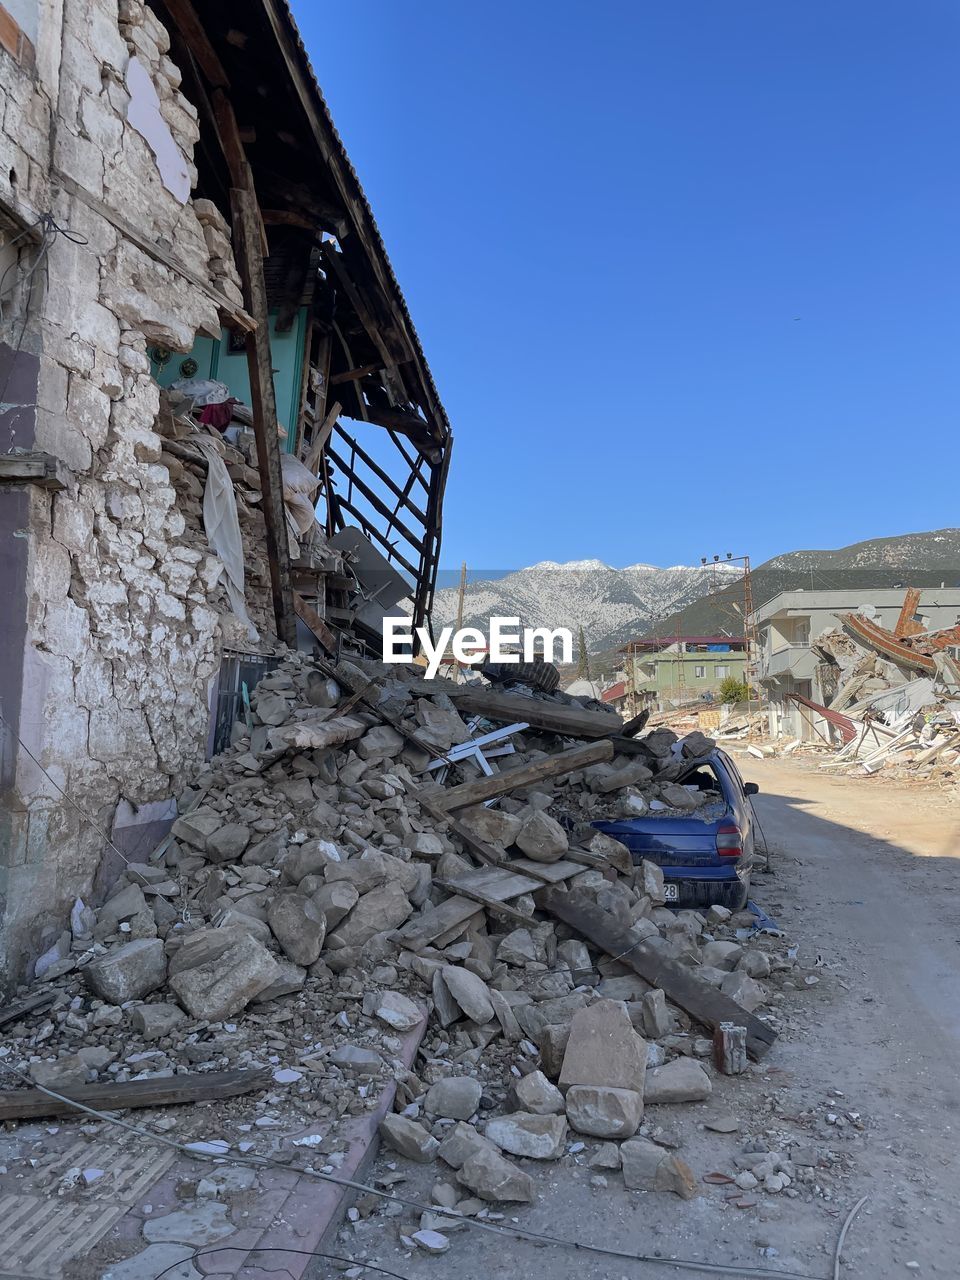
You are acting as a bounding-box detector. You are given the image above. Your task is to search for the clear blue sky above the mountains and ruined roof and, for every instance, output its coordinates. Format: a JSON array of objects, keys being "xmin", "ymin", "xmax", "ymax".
[{"xmin": 293, "ymin": 0, "xmax": 960, "ymax": 568}]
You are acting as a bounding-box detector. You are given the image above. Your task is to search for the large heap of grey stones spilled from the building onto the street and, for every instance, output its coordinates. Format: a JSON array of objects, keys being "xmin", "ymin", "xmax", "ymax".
[{"xmin": 5, "ymin": 653, "xmax": 815, "ymax": 1231}]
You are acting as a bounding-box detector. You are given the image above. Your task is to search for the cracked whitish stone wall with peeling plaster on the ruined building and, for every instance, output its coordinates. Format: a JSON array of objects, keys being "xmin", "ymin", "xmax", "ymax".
[{"xmin": 0, "ymin": 0, "xmax": 271, "ymax": 980}]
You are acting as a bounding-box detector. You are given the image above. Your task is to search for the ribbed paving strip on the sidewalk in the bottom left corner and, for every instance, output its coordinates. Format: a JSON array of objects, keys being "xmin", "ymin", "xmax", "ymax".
[{"xmin": 0, "ymin": 1135, "xmax": 174, "ymax": 1280}]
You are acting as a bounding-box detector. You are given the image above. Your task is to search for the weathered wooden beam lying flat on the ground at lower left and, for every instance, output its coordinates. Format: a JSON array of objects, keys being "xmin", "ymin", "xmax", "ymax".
[{"xmin": 0, "ymin": 1069, "xmax": 273, "ymax": 1123}]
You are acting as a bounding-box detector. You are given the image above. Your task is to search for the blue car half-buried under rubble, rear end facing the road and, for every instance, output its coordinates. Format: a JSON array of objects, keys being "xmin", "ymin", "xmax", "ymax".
[{"xmin": 591, "ymin": 750, "xmax": 760, "ymax": 911}]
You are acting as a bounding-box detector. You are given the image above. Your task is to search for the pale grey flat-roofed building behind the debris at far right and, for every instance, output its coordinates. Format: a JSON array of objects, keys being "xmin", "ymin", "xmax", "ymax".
[{"xmin": 753, "ymin": 586, "xmax": 960, "ymax": 739}]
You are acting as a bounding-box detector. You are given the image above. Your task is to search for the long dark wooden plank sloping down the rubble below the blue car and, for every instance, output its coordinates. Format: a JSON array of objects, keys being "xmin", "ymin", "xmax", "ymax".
[{"xmin": 540, "ymin": 888, "xmax": 777, "ymax": 1059}]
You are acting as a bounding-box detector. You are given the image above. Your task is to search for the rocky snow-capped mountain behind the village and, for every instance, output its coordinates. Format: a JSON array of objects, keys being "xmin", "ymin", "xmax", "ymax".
[{"xmin": 433, "ymin": 559, "xmax": 741, "ymax": 653}]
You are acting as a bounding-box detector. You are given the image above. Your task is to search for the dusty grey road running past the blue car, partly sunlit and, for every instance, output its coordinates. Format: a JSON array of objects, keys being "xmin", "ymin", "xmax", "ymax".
[{"xmin": 327, "ymin": 756, "xmax": 960, "ymax": 1280}]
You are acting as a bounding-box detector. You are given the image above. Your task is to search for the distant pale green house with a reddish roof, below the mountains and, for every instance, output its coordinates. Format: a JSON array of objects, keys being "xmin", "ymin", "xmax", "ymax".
[{"xmin": 618, "ymin": 635, "xmax": 746, "ymax": 716}]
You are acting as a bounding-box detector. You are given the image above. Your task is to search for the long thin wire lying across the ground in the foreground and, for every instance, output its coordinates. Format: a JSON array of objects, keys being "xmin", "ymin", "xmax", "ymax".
[{"xmin": 0, "ymin": 1062, "xmax": 839, "ymax": 1280}]
